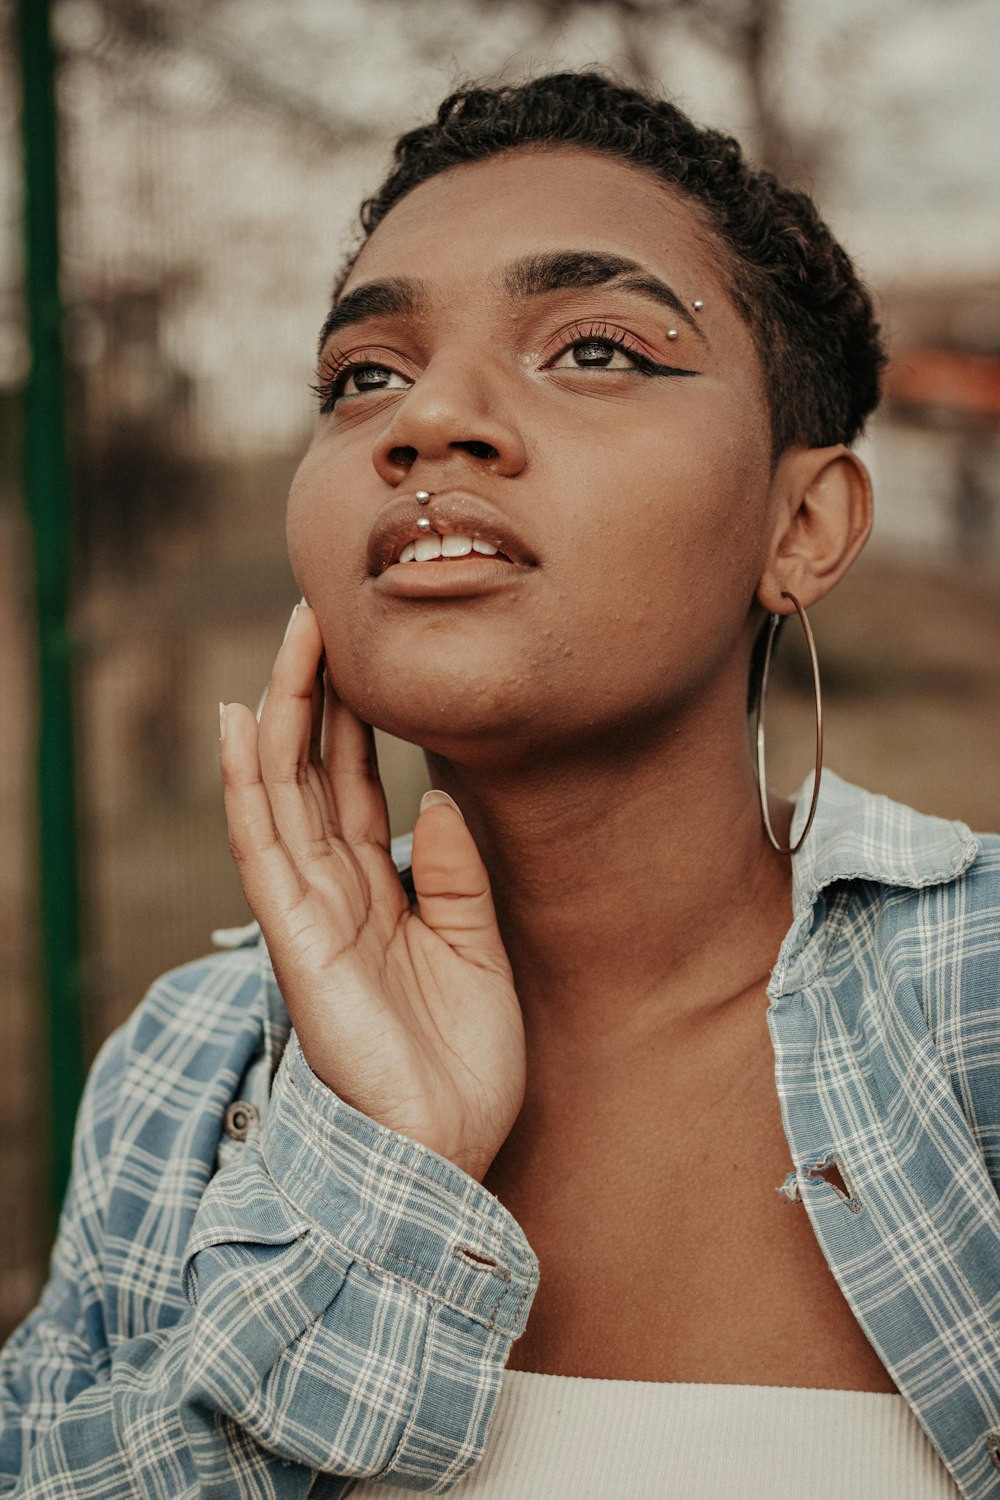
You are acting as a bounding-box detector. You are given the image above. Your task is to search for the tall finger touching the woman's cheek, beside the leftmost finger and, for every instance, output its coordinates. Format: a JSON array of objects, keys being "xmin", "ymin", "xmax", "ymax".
[{"xmin": 259, "ymin": 605, "xmax": 336, "ymax": 863}]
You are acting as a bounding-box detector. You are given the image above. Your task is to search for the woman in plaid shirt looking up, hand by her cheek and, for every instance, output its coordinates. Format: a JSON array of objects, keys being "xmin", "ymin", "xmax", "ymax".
[{"xmin": 7, "ymin": 75, "xmax": 1000, "ymax": 1497}]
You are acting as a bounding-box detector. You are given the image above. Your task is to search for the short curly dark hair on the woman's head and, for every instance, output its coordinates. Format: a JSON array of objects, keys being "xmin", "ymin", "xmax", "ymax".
[{"xmin": 340, "ymin": 72, "xmax": 885, "ymax": 459}]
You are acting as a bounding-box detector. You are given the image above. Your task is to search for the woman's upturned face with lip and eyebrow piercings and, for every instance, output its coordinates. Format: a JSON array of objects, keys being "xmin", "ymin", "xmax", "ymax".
[{"xmin": 288, "ymin": 149, "xmax": 774, "ymax": 759}]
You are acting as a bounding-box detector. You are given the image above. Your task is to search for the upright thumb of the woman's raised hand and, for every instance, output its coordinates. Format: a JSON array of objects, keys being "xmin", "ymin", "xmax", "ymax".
[{"xmin": 411, "ymin": 791, "xmax": 510, "ymax": 969}]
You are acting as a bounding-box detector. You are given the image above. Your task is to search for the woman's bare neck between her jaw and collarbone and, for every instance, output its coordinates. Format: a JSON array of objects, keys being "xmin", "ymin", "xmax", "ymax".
[{"xmin": 429, "ymin": 690, "xmax": 792, "ymax": 1046}]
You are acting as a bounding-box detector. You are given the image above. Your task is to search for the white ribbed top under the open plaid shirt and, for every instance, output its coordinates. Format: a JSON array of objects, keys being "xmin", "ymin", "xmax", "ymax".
[{"xmin": 351, "ymin": 1370, "xmax": 960, "ymax": 1500}]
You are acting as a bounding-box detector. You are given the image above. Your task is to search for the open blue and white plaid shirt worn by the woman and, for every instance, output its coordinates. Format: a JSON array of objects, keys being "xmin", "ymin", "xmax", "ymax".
[{"xmin": 0, "ymin": 776, "xmax": 1000, "ymax": 1500}]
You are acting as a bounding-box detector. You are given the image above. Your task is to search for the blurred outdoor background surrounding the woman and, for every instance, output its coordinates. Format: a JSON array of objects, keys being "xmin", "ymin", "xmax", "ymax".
[{"xmin": 0, "ymin": 0, "xmax": 1000, "ymax": 1332}]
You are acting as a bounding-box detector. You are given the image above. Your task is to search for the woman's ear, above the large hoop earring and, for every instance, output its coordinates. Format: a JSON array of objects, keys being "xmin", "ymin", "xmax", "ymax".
[{"xmin": 757, "ymin": 443, "xmax": 871, "ymax": 615}]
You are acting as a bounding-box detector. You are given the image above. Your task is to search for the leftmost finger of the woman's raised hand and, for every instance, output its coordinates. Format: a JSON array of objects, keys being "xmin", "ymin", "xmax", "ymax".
[{"xmin": 219, "ymin": 704, "xmax": 303, "ymax": 926}]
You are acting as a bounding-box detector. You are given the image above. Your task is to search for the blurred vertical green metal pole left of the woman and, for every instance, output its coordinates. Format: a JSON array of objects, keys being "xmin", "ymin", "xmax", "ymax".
[{"xmin": 18, "ymin": 0, "xmax": 84, "ymax": 1209}]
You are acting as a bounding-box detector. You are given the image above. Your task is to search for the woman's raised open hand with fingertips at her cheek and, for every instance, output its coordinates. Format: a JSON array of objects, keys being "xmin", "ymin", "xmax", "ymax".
[{"xmin": 222, "ymin": 605, "xmax": 525, "ymax": 1181}]
